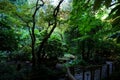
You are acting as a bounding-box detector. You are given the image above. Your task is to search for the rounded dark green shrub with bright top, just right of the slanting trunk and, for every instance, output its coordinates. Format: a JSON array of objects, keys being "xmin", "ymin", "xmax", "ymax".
[{"xmin": 45, "ymin": 35, "xmax": 66, "ymax": 57}]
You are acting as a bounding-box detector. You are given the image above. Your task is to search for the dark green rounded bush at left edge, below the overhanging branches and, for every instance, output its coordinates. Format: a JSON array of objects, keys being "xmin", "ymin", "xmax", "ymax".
[{"xmin": 0, "ymin": 16, "xmax": 19, "ymax": 51}]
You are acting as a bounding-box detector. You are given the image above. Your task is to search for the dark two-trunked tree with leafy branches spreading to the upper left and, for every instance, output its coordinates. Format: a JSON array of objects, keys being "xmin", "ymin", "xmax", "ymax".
[{"xmin": 0, "ymin": 0, "xmax": 63, "ymax": 66}]
